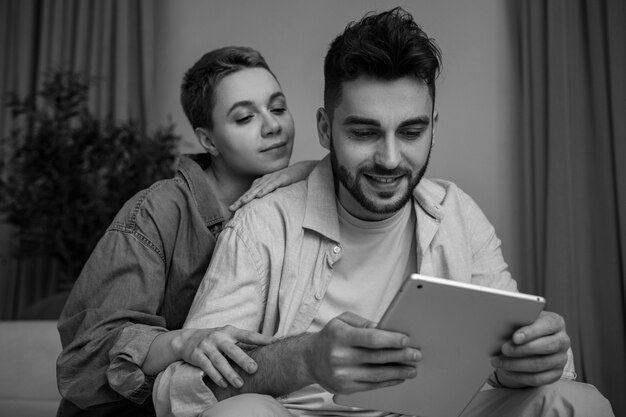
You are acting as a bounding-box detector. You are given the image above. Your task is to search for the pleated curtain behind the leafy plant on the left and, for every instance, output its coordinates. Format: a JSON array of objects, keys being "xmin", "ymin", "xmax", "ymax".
[{"xmin": 0, "ymin": 0, "xmax": 155, "ymax": 319}]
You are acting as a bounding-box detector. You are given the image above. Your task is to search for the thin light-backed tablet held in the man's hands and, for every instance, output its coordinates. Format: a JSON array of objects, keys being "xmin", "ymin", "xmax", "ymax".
[{"xmin": 334, "ymin": 274, "xmax": 545, "ymax": 417}]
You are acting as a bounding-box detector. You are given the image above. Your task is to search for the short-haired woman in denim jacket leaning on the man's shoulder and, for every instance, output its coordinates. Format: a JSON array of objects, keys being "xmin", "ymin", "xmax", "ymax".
[{"xmin": 57, "ymin": 47, "xmax": 312, "ymax": 416}]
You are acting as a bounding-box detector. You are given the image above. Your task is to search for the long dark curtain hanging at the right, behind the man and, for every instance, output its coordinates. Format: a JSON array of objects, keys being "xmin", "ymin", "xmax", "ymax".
[{"xmin": 516, "ymin": 0, "xmax": 626, "ymax": 415}]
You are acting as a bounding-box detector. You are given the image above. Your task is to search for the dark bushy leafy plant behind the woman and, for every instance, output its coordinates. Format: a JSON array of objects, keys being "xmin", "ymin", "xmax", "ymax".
[{"xmin": 0, "ymin": 71, "xmax": 180, "ymax": 316}]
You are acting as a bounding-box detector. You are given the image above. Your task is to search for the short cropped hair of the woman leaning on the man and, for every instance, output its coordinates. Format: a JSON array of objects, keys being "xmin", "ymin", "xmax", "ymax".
[{"xmin": 180, "ymin": 46, "xmax": 276, "ymax": 129}]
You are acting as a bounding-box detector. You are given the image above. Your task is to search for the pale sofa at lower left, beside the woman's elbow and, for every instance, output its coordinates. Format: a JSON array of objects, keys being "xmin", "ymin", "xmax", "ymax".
[{"xmin": 0, "ymin": 320, "xmax": 61, "ymax": 417}]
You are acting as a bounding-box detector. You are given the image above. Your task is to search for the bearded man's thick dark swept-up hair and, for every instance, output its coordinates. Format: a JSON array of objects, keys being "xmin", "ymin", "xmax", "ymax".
[{"xmin": 324, "ymin": 7, "xmax": 441, "ymax": 117}]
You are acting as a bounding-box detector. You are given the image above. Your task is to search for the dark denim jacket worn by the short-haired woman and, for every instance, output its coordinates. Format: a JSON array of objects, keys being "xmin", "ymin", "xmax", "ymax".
[{"xmin": 57, "ymin": 157, "xmax": 225, "ymax": 416}]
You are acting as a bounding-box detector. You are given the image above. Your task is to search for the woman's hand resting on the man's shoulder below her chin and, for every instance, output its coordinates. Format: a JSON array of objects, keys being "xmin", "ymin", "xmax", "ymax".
[{"xmin": 228, "ymin": 161, "xmax": 317, "ymax": 211}]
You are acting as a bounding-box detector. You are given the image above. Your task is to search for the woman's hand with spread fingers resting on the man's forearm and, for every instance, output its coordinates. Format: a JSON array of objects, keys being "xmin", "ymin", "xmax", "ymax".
[{"xmin": 172, "ymin": 326, "xmax": 275, "ymax": 388}]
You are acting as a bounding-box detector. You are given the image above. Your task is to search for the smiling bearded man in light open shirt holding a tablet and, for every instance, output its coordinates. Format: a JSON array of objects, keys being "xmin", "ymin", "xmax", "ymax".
[{"xmin": 154, "ymin": 9, "xmax": 612, "ymax": 416}]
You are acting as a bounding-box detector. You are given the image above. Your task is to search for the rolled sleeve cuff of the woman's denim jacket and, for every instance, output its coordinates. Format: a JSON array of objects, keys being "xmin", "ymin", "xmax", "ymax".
[{"xmin": 106, "ymin": 325, "xmax": 167, "ymax": 404}]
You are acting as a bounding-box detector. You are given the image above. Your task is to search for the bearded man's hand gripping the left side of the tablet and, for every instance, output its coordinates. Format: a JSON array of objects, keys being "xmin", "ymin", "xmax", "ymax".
[{"xmin": 305, "ymin": 312, "xmax": 422, "ymax": 394}]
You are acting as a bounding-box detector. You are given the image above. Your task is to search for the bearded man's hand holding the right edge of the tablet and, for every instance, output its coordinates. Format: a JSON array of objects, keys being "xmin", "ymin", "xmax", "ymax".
[{"xmin": 491, "ymin": 311, "xmax": 570, "ymax": 388}]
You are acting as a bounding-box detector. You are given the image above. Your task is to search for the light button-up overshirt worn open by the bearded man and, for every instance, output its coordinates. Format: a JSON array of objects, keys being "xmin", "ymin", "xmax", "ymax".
[{"xmin": 154, "ymin": 157, "xmax": 572, "ymax": 416}]
